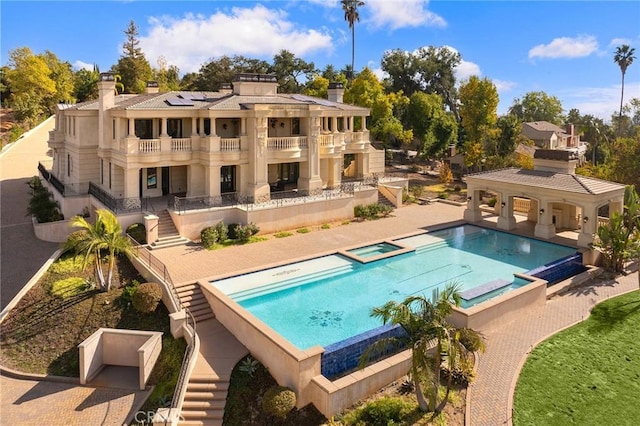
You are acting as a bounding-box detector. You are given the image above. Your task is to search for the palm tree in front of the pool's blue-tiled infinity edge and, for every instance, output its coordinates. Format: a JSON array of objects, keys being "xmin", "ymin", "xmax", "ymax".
[{"xmin": 360, "ymin": 284, "xmax": 484, "ymax": 413}]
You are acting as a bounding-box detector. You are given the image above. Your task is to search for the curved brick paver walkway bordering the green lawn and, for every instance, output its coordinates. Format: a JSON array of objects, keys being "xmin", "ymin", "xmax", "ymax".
[{"xmin": 468, "ymin": 272, "xmax": 638, "ymax": 426}]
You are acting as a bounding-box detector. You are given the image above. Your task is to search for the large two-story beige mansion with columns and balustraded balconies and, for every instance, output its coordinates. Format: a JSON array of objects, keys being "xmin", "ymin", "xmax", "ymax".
[{"xmin": 40, "ymin": 73, "xmax": 384, "ymax": 237}]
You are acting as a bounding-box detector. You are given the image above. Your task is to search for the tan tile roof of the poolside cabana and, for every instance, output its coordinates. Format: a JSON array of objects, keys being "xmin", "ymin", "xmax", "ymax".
[{"xmin": 466, "ymin": 168, "xmax": 624, "ymax": 195}]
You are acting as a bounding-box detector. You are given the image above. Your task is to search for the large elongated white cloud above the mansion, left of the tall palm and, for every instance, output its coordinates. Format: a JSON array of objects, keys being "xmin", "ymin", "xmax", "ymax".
[{"xmin": 140, "ymin": 5, "xmax": 332, "ymax": 73}]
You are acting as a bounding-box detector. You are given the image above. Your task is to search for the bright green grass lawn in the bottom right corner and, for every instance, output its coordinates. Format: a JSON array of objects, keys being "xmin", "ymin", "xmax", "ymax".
[{"xmin": 513, "ymin": 291, "xmax": 640, "ymax": 426}]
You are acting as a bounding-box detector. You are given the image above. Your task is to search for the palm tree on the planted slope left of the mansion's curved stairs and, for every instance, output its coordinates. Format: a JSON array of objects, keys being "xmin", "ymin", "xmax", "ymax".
[{"xmin": 64, "ymin": 209, "xmax": 131, "ymax": 291}]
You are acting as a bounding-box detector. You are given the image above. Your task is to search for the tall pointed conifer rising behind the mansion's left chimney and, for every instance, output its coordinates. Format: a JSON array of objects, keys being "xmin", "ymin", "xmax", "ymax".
[{"xmin": 111, "ymin": 20, "xmax": 153, "ymax": 93}]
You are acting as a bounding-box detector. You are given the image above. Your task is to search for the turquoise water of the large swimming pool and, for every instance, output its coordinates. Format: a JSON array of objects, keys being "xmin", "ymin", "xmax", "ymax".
[{"xmin": 213, "ymin": 225, "xmax": 575, "ymax": 349}]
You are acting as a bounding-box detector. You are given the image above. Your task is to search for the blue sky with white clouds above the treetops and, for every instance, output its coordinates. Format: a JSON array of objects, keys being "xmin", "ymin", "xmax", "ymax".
[{"xmin": 0, "ymin": 0, "xmax": 640, "ymax": 121}]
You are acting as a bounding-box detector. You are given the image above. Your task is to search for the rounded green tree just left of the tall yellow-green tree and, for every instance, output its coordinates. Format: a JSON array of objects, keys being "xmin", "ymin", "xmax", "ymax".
[{"xmin": 405, "ymin": 92, "xmax": 458, "ymax": 157}]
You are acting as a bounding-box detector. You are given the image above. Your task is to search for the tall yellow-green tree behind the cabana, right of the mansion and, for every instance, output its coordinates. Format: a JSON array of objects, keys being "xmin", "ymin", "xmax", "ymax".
[{"xmin": 458, "ymin": 76, "xmax": 499, "ymax": 146}]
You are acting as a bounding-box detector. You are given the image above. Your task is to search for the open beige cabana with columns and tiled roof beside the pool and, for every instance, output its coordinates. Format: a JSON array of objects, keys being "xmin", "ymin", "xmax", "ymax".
[{"xmin": 464, "ymin": 150, "xmax": 624, "ymax": 247}]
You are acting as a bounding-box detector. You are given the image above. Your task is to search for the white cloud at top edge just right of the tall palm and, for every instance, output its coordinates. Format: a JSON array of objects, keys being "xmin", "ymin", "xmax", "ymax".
[{"xmin": 360, "ymin": 0, "xmax": 447, "ymax": 30}]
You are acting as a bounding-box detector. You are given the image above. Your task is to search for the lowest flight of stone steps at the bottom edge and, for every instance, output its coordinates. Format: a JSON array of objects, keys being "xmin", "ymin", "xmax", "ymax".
[{"xmin": 178, "ymin": 375, "xmax": 229, "ymax": 426}]
